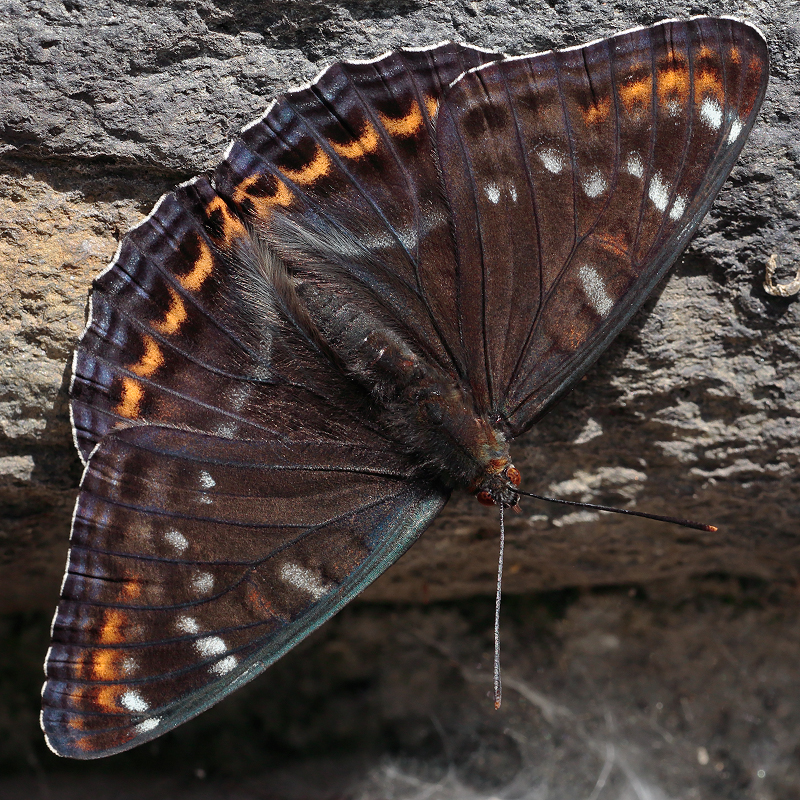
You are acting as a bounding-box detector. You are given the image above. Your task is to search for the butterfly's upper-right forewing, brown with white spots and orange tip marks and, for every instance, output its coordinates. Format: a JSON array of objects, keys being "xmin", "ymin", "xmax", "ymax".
[{"xmin": 437, "ymin": 18, "xmax": 768, "ymax": 436}]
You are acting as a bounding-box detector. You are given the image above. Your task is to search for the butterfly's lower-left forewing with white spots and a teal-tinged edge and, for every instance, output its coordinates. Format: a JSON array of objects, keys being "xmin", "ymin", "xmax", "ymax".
[{"xmin": 42, "ymin": 426, "xmax": 446, "ymax": 758}]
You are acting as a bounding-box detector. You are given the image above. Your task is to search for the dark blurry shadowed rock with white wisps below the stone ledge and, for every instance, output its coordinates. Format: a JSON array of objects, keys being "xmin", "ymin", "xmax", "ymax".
[{"xmin": 0, "ymin": 578, "xmax": 800, "ymax": 800}]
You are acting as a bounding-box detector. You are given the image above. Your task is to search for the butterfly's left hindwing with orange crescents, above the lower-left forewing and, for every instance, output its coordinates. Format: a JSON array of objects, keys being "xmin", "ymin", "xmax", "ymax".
[{"xmin": 70, "ymin": 179, "xmax": 366, "ymax": 462}]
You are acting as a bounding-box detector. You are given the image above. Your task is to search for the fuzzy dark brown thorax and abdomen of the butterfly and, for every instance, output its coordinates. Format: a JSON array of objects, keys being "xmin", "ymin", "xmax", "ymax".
[{"xmin": 260, "ymin": 244, "xmax": 508, "ymax": 489}]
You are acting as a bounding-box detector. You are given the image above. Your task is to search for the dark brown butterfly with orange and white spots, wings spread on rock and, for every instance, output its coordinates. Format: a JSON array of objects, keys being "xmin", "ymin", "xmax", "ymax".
[{"xmin": 42, "ymin": 17, "xmax": 768, "ymax": 758}]
